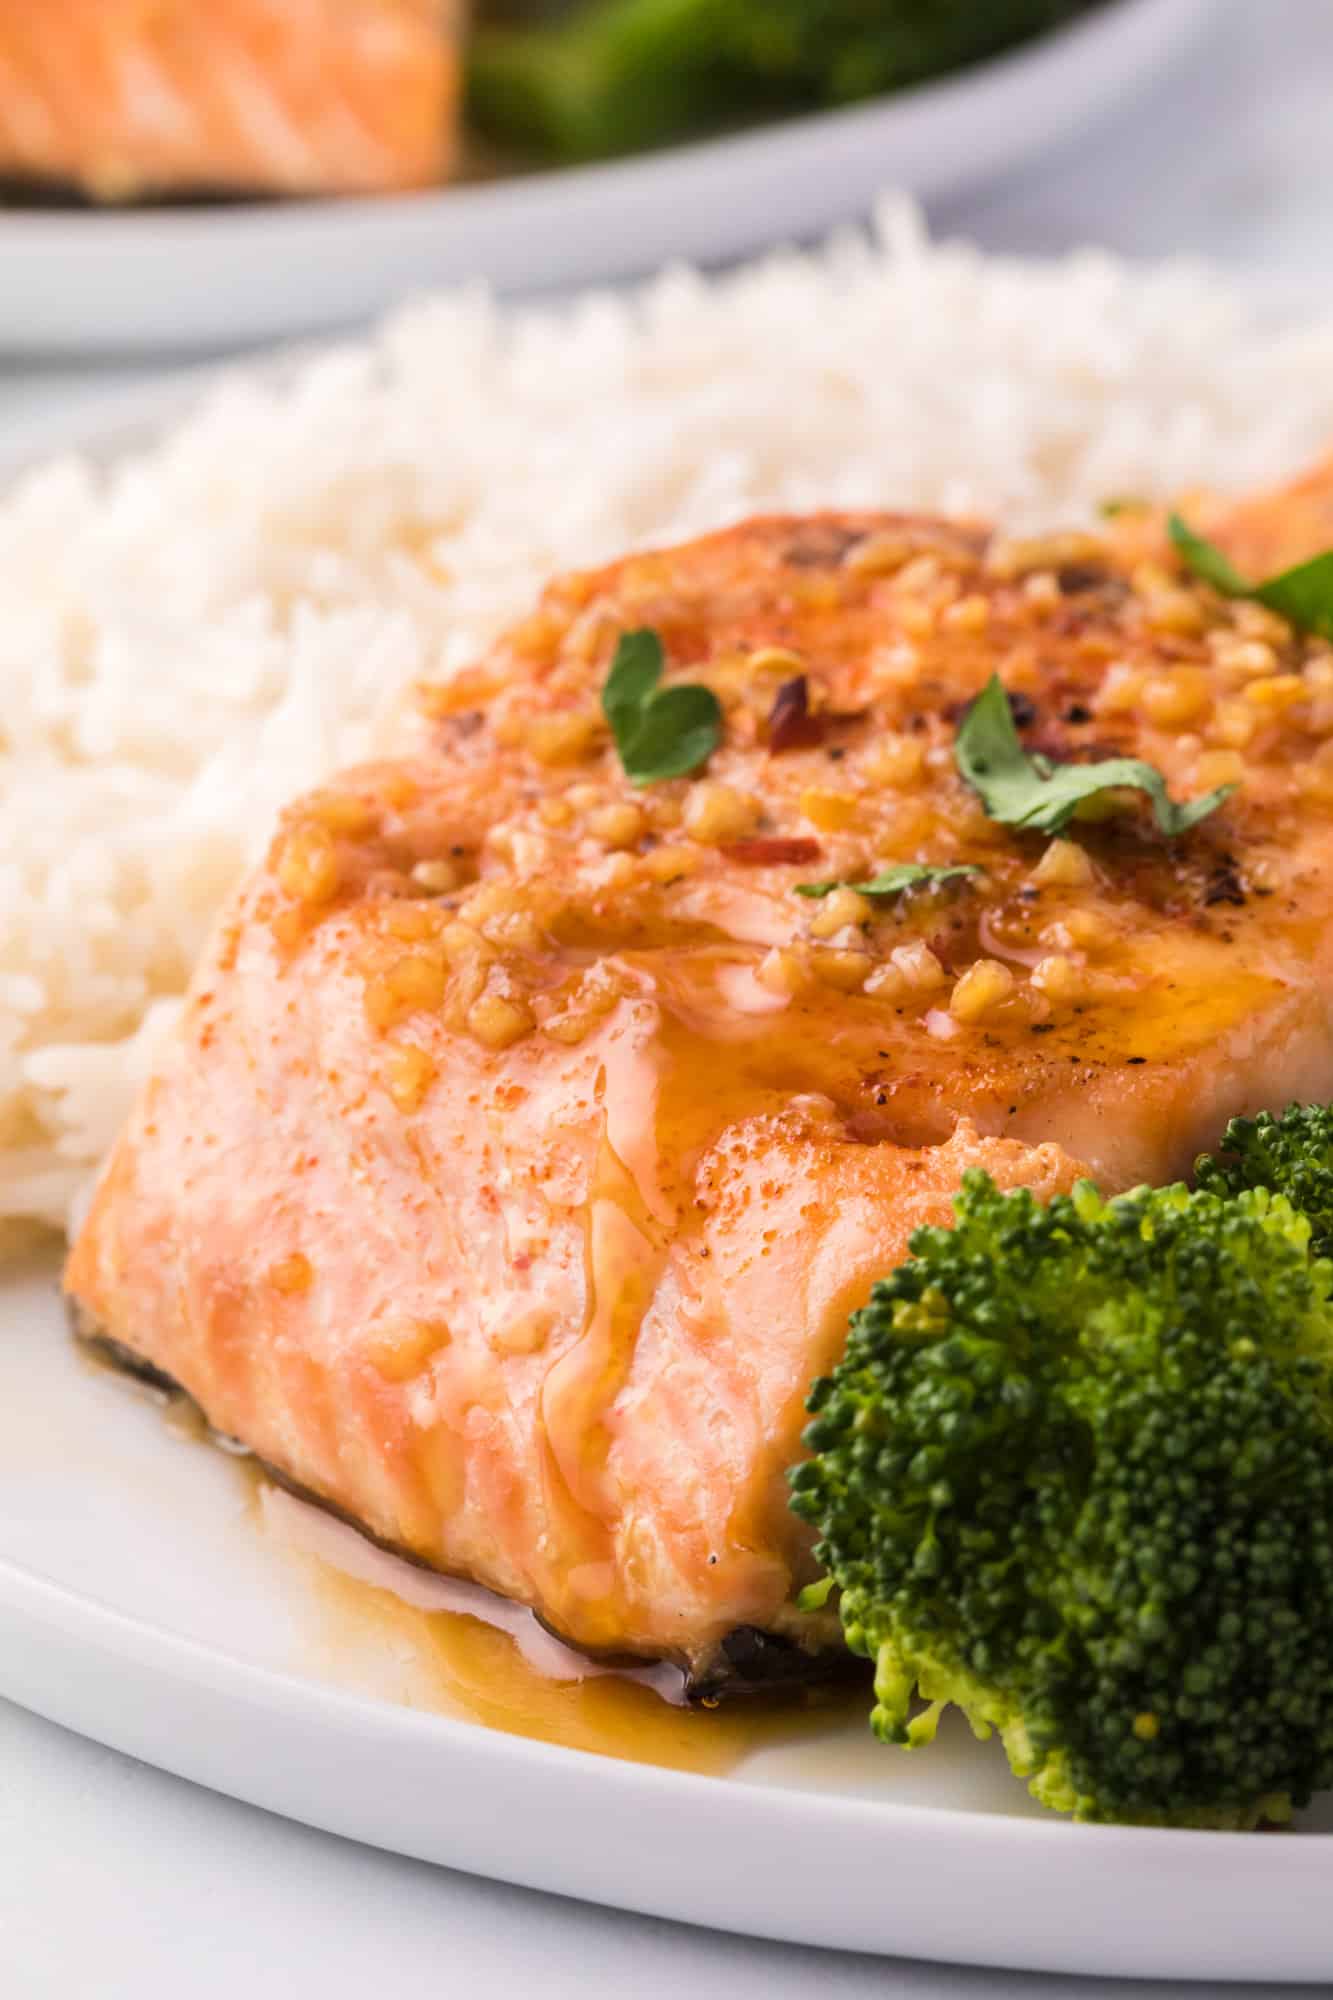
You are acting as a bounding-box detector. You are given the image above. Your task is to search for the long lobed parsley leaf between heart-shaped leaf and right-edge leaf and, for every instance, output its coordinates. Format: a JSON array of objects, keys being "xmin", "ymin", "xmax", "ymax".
[{"xmin": 953, "ymin": 674, "xmax": 1235, "ymax": 838}]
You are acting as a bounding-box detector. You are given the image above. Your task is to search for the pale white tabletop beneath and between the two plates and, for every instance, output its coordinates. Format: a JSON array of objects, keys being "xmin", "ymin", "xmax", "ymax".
[{"xmin": 0, "ymin": 0, "xmax": 1333, "ymax": 2000}]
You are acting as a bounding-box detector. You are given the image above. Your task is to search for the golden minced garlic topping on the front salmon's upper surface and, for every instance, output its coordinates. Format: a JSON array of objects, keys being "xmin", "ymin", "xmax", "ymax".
[{"xmin": 260, "ymin": 498, "xmax": 1333, "ymax": 1110}]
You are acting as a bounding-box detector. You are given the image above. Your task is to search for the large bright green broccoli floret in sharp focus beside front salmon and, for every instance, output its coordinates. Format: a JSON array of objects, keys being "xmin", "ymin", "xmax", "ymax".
[{"xmin": 793, "ymin": 1172, "xmax": 1333, "ymax": 1826}]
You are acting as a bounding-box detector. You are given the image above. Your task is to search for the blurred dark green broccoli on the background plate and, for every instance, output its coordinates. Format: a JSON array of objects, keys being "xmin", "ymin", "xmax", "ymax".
[{"xmin": 468, "ymin": 0, "xmax": 1093, "ymax": 160}]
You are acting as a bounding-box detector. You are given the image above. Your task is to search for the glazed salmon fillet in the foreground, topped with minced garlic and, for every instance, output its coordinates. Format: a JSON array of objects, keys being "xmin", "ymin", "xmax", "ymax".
[{"xmin": 68, "ymin": 480, "xmax": 1333, "ymax": 1678}]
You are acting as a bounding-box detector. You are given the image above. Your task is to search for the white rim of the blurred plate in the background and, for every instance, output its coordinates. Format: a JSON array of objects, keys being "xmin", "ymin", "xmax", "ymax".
[{"xmin": 0, "ymin": 0, "xmax": 1209, "ymax": 354}]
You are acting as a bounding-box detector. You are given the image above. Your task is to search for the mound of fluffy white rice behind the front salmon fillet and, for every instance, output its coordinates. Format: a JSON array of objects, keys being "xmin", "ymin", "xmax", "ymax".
[{"xmin": 0, "ymin": 204, "xmax": 1333, "ymax": 1228}]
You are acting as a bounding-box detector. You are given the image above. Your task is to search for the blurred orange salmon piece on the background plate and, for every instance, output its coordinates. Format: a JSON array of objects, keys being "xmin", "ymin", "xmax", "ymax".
[{"xmin": 0, "ymin": 0, "xmax": 458, "ymax": 200}]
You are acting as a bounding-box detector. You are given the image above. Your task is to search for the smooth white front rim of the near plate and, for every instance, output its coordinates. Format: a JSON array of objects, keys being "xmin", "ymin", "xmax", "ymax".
[{"xmin": 0, "ymin": 1520, "xmax": 1333, "ymax": 1982}]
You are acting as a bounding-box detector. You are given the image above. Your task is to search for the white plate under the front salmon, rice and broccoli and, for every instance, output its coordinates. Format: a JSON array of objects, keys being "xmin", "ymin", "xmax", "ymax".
[{"xmin": 0, "ymin": 1266, "xmax": 1333, "ymax": 1980}]
